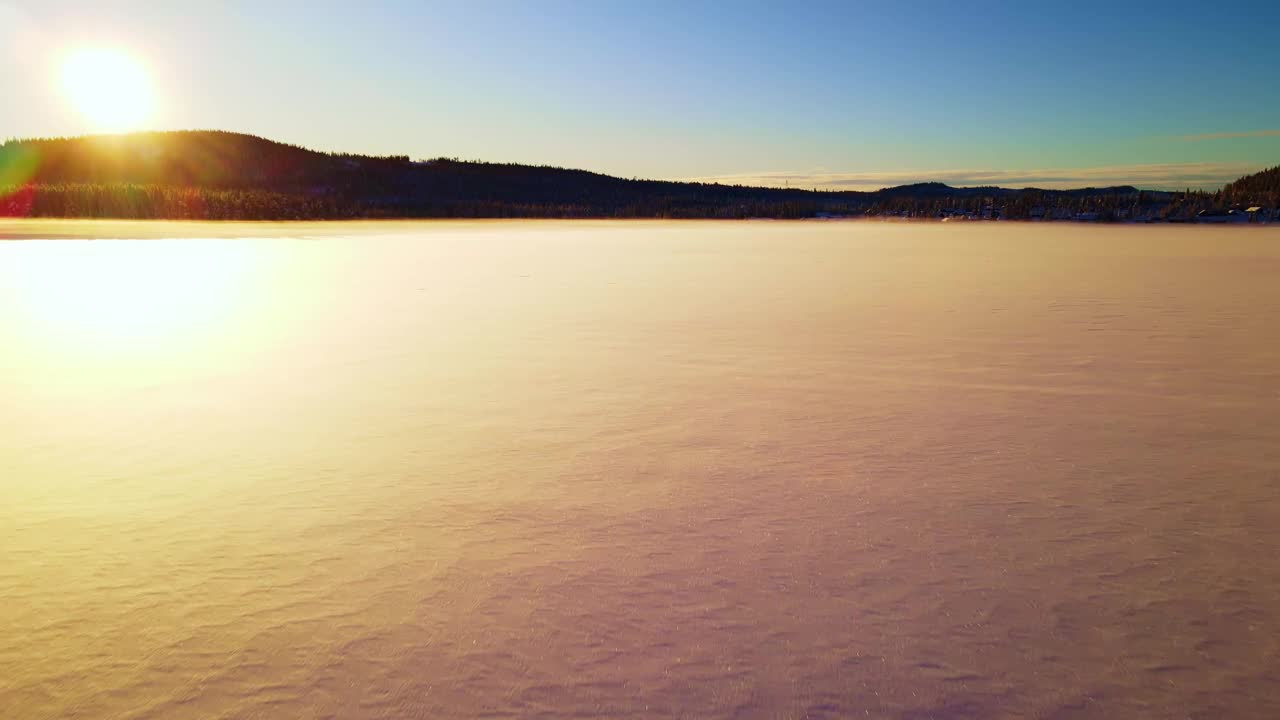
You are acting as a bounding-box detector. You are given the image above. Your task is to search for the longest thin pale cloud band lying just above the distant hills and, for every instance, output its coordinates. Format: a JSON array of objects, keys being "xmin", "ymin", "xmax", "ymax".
[{"xmin": 684, "ymin": 163, "xmax": 1261, "ymax": 191}]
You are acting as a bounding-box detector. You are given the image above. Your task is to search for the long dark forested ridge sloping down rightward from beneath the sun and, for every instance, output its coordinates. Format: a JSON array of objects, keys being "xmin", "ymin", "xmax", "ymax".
[{"xmin": 0, "ymin": 131, "xmax": 1274, "ymax": 219}]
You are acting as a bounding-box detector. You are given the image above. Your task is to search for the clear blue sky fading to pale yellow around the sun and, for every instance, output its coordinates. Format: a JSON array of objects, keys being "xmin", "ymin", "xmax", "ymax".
[{"xmin": 0, "ymin": 0, "xmax": 1280, "ymax": 190}]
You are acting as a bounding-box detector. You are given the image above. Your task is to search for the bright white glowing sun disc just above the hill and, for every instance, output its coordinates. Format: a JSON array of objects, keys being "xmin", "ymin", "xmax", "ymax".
[{"xmin": 61, "ymin": 47, "xmax": 155, "ymax": 132}]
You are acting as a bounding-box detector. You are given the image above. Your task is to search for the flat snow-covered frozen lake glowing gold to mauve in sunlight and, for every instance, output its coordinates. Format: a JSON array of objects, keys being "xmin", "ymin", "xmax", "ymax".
[{"xmin": 0, "ymin": 222, "xmax": 1280, "ymax": 719}]
